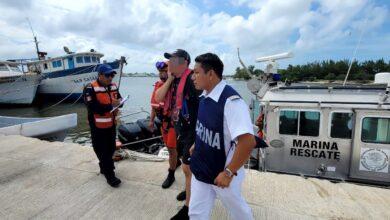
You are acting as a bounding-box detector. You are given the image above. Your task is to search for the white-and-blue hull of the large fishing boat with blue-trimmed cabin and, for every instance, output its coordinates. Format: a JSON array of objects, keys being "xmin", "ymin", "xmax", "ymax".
[{"xmin": 38, "ymin": 61, "xmax": 120, "ymax": 101}]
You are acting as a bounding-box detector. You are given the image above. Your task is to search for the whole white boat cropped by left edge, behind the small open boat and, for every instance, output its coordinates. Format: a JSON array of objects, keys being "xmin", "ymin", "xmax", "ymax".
[{"xmin": 0, "ymin": 61, "xmax": 40, "ymax": 105}]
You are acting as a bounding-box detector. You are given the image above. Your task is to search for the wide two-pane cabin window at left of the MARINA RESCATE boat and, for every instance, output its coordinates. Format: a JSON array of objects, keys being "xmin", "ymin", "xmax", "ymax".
[{"xmin": 279, "ymin": 110, "xmax": 320, "ymax": 137}]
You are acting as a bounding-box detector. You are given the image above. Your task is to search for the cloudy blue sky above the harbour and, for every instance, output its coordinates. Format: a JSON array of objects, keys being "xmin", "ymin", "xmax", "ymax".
[{"xmin": 0, "ymin": 0, "xmax": 390, "ymax": 75}]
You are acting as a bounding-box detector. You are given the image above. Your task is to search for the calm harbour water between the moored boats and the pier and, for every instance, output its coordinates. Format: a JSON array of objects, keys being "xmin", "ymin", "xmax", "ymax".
[{"xmin": 0, "ymin": 77, "xmax": 254, "ymax": 144}]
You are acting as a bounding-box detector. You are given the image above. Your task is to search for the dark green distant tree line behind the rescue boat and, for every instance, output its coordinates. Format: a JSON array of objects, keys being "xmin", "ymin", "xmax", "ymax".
[{"xmin": 233, "ymin": 59, "xmax": 390, "ymax": 82}]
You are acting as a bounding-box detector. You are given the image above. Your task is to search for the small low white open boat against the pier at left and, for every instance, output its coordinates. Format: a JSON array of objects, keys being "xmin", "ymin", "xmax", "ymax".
[{"xmin": 0, "ymin": 113, "xmax": 77, "ymax": 141}]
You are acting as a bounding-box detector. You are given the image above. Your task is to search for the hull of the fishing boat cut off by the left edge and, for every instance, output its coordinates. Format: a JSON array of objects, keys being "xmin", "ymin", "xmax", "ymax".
[{"xmin": 0, "ymin": 75, "xmax": 41, "ymax": 105}]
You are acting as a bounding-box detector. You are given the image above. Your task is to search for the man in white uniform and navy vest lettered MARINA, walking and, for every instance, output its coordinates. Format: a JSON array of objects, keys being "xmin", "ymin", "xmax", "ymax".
[{"xmin": 189, "ymin": 53, "xmax": 256, "ymax": 220}]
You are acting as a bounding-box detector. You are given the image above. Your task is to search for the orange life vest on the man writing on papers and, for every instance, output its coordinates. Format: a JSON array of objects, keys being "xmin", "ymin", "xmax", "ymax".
[{"xmin": 91, "ymin": 81, "xmax": 118, "ymax": 128}]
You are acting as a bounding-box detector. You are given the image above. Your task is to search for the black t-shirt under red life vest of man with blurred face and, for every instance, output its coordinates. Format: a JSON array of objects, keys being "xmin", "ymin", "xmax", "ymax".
[{"xmin": 173, "ymin": 72, "xmax": 202, "ymax": 136}]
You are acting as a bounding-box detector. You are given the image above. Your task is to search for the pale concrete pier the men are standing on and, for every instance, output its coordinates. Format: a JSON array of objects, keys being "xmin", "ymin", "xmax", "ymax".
[{"xmin": 0, "ymin": 136, "xmax": 390, "ymax": 219}]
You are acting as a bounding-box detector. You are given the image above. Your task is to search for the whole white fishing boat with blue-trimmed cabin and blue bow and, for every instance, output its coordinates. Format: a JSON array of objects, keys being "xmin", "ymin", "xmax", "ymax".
[{"xmin": 27, "ymin": 47, "xmax": 125, "ymax": 101}]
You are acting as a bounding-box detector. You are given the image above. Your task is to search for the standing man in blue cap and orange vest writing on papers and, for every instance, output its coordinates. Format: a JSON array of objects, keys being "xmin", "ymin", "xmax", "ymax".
[{"xmin": 83, "ymin": 64, "xmax": 121, "ymax": 187}]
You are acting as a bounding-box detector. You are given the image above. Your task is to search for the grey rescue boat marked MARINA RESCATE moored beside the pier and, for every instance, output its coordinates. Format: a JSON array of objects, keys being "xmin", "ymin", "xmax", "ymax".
[{"xmin": 248, "ymin": 54, "xmax": 390, "ymax": 185}]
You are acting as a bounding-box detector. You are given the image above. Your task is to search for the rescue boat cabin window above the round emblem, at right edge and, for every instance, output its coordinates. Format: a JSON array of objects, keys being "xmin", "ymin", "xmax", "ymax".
[{"xmin": 362, "ymin": 117, "xmax": 390, "ymax": 144}]
